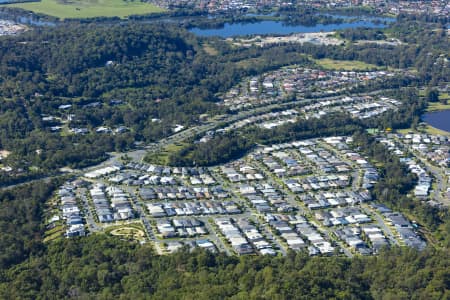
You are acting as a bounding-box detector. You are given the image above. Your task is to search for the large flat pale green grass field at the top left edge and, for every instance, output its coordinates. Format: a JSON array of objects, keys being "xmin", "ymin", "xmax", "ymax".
[{"xmin": 5, "ymin": 0, "xmax": 164, "ymax": 19}]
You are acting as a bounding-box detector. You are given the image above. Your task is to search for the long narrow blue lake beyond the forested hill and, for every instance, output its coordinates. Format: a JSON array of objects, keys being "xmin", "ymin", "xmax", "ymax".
[{"xmin": 190, "ymin": 18, "xmax": 387, "ymax": 38}]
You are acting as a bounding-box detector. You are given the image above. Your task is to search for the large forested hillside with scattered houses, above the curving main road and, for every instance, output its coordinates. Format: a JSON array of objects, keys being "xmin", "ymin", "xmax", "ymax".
[{"xmin": 0, "ymin": 23, "xmax": 311, "ymax": 183}]
